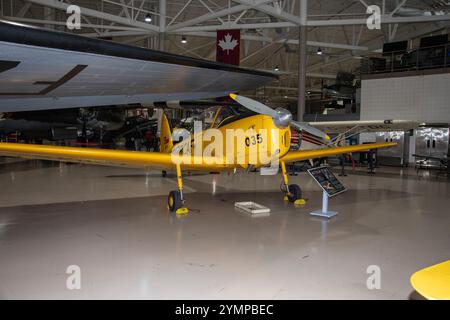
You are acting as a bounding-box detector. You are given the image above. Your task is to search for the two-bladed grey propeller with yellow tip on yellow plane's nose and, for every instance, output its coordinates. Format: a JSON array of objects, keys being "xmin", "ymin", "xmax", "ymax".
[{"xmin": 230, "ymin": 94, "xmax": 330, "ymax": 140}]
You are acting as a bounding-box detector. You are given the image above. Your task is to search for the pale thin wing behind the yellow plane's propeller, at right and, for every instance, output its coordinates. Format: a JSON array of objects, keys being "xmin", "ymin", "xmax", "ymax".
[{"xmin": 309, "ymin": 120, "xmax": 419, "ymax": 134}]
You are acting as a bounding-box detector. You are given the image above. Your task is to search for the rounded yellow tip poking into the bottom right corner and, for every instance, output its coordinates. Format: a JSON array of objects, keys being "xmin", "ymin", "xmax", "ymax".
[{"xmin": 411, "ymin": 260, "xmax": 450, "ymax": 300}]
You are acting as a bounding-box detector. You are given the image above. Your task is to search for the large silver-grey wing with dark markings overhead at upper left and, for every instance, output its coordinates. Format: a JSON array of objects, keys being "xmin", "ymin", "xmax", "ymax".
[{"xmin": 0, "ymin": 21, "xmax": 277, "ymax": 112}]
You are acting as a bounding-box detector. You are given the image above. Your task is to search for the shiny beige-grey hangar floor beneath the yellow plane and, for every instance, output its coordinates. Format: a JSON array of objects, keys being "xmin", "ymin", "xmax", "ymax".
[{"xmin": 0, "ymin": 159, "xmax": 450, "ymax": 299}]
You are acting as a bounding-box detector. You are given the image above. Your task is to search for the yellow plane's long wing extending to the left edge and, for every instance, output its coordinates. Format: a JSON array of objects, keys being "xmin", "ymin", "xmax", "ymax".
[{"xmin": 0, "ymin": 143, "xmax": 227, "ymax": 170}]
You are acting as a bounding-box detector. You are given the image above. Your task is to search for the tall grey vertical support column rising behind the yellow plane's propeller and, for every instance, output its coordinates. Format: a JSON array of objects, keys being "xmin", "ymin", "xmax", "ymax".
[{"xmin": 297, "ymin": 0, "xmax": 308, "ymax": 122}]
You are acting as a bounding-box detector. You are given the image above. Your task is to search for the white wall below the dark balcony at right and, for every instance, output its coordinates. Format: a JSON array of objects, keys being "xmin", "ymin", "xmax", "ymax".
[{"xmin": 361, "ymin": 74, "xmax": 450, "ymax": 123}]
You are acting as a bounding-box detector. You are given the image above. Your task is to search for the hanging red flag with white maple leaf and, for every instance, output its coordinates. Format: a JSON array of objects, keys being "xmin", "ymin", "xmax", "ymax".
[{"xmin": 216, "ymin": 30, "xmax": 241, "ymax": 66}]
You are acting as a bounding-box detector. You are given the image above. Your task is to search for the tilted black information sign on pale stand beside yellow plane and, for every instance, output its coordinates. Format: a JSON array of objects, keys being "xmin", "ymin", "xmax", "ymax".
[{"xmin": 308, "ymin": 167, "xmax": 346, "ymax": 218}]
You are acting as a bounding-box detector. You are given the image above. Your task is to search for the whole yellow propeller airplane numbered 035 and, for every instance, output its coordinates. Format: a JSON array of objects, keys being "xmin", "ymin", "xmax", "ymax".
[{"xmin": 0, "ymin": 94, "xmax": 396, "ymax": 214}]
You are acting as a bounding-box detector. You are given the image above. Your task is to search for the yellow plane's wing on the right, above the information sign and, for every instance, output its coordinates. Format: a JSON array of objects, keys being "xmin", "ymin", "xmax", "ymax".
[{"xmin": 282, "ymin": 142, "xmax": 397, "ymax": 163}]
